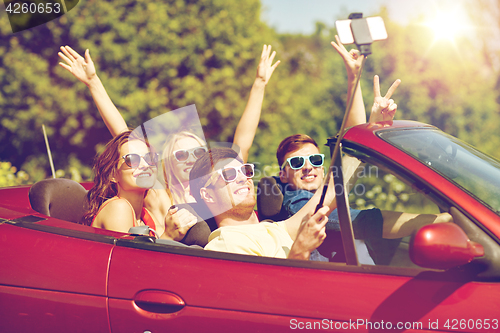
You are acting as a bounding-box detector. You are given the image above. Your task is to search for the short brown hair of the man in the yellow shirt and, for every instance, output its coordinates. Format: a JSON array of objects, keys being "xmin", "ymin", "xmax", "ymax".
[{"xmin": 189, "ymin": 148, "xmax": 243, "ymax": 203}]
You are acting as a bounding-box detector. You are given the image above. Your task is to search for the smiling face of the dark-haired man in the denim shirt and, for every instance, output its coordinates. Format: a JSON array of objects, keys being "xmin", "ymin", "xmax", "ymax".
[{"xmin": 280, "ymin": 143, "xmax": 324, "ymax": 192}]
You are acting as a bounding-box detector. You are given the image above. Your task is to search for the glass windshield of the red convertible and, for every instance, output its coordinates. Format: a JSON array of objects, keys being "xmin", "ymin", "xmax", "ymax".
[{"xmin": 378, "ymin": 128, "xmax": 500, "ymax": 214}]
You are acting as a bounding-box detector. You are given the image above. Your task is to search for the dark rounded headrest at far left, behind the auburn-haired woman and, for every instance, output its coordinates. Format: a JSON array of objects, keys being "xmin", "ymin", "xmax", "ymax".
[{"xmin": 29, "ymin": 178, "xmax": 88, "ymax": 222}]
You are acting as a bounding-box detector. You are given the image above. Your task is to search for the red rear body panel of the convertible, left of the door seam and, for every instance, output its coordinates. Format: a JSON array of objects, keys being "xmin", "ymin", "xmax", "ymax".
[{"xmin": 0, "ymin": 209, "xmax": 114, "ymax": 332}]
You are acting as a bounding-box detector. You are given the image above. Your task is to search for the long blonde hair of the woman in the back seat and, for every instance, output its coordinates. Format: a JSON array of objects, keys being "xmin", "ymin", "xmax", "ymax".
[{"xmin": 162, "ymin": 131, "xmax": 206, "ymax": 204}]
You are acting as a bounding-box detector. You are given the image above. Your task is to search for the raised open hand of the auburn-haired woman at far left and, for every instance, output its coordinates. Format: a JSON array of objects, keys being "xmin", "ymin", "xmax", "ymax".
[{"xmin": 58, "ymin": 46, "xmax": 97, "ymax": 86}]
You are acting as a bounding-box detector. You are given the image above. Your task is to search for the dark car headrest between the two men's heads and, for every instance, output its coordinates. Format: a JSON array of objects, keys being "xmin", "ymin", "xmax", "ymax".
[{"xmin": 257, "ymin": 176, "xmax": 288, "ymax": 221}]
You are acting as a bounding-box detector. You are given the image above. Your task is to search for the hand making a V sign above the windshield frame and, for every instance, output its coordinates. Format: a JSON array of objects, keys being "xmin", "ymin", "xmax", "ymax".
[{"xmin": 368, "ymin": 75, "xmax": 401, "ymax": 124}]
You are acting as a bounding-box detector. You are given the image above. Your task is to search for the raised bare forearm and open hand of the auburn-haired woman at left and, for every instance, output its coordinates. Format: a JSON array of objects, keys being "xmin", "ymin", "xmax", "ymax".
[{"xmin": 58, "ymin": 46, "xmax": 128, "ymax": 137}]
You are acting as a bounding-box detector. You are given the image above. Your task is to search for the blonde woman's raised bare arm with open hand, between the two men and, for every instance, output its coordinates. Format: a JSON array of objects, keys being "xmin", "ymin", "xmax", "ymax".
[{"xmin": 234, "ymin": 45, "xmax": 280, "ymax": 162}]
